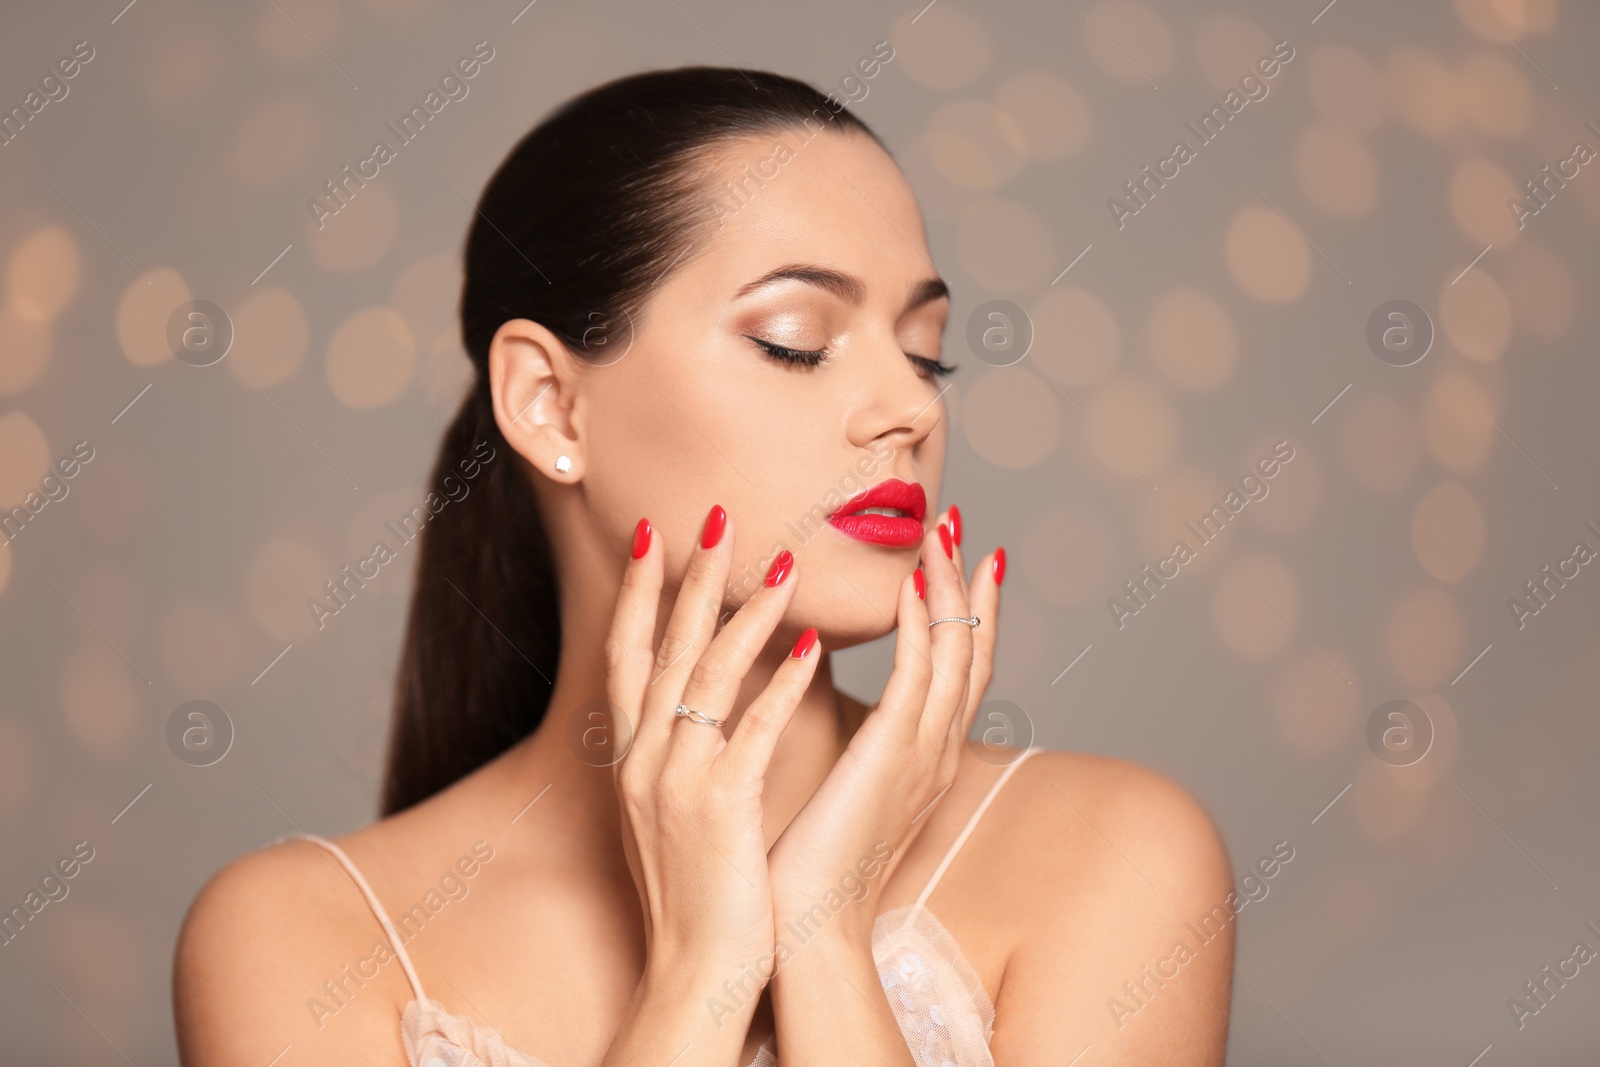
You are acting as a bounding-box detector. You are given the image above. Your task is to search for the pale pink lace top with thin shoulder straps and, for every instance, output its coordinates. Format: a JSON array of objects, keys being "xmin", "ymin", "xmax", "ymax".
[{"xmin": 307, "ymin": 749, "xmax": 1037, "ymax": 1067}]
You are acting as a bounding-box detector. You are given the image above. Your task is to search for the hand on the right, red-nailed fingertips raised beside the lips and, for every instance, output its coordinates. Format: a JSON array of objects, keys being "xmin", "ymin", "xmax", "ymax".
[{"xmin": 768, "ymin": 512, "xmax": 1000, "ymax": 947}]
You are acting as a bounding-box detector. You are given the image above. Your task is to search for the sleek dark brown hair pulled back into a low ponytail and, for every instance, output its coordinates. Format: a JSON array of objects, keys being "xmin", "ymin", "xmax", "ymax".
[{"xmin": 382, "ymin": 67, "xmax": 877, "ymax": 814}]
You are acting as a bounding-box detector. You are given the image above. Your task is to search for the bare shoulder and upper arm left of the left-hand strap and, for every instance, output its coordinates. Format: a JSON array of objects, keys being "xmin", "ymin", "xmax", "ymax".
[{"xmin": 173, "ymin": 840, "xmax": 406, "ymax": 1067}]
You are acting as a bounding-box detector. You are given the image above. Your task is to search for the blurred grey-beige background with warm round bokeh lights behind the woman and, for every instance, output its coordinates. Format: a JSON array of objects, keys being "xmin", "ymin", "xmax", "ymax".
[{"xmin": 0, "ymin": 0, "xmax": 1600, "ymax": 1067}]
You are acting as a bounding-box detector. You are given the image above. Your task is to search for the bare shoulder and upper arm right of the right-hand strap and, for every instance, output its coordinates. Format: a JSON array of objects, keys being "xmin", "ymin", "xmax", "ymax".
[{"xmin": 971, "ymin": 747, "xmax": 1237, "ymax": 1065}]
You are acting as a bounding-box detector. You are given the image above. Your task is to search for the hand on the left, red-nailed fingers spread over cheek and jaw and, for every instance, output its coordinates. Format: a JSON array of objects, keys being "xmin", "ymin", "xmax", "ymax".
[{"xmin": 605, "ymin": 507, "xmax": 821, "ymax": 1035}]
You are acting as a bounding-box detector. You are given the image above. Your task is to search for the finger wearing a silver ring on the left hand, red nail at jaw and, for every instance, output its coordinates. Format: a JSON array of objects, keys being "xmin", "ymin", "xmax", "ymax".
[{"xmin": 667, "ymin": 549, "xmax": 798, "ymax": 765}]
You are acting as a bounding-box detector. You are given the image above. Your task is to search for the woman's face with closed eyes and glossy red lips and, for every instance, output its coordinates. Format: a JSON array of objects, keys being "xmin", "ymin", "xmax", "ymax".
[{"xmin": 579, "ymin": 130, "xmax": 949, "ymax": 648}]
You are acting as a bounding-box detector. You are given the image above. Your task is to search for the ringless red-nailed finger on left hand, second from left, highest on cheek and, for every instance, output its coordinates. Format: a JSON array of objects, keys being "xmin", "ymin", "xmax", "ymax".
[{"xmin": 638, "ymin": 504, "xmax": 733, "ymax": 744}]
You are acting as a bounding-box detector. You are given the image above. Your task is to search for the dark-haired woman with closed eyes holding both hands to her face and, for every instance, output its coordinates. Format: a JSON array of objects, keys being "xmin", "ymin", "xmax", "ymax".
[{"xmin": 174, "ymin": 69, "xmax": 1232, "ymax": 1067}]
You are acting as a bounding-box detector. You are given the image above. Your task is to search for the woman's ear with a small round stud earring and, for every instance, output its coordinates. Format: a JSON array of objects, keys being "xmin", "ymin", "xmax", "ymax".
[{"xmin": 490, "ymin": 318, "xmax": 584, "ymax": 483}]
